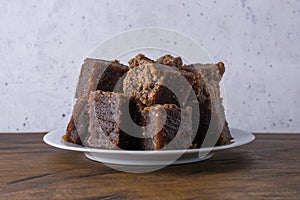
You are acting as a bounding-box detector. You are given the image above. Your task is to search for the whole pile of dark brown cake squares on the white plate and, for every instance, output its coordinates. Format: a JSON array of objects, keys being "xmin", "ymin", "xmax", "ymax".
[{"xmin": 63, "ymin": 54, "xmax": 232, "ymax": 150}]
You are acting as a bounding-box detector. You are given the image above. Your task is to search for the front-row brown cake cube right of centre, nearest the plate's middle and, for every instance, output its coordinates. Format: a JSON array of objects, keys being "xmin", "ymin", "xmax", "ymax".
[{"xmin": 142, "ymin": 104, "xmax": 192, "ymax": 150}]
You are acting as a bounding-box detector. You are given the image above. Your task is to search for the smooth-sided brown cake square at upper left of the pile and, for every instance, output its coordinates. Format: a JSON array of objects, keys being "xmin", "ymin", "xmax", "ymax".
[{"xmin": 75, "ymin": 58, "xmax": 128, "ymax": 98}]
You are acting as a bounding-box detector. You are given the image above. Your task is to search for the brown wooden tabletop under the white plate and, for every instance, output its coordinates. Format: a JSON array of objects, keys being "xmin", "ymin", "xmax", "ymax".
[{"xmin": 0, "ymin": 133, "xmax": 300, "ymax": 200}]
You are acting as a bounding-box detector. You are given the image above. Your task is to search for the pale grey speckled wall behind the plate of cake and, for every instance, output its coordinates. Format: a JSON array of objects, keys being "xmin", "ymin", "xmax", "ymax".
[{"xmin": 0, "ymin": 0, "xmax": 300, "ymax": 132}]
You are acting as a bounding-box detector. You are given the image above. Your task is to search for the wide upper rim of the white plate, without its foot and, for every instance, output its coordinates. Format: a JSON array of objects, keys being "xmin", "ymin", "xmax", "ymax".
[{"xmin": 43, "ymin": 128, "xmax": 255, "ymax": 155}]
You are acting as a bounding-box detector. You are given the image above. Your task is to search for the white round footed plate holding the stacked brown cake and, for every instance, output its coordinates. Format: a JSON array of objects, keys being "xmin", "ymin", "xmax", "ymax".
[{"xmin": 43, "ymin": 128, "xmax": 255, "ymax": 166}]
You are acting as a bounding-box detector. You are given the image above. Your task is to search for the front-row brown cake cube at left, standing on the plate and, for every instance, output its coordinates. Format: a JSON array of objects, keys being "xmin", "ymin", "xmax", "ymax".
[{"xmin": 86, "ymin": 90, "xmax": 142, "ymax": 150}]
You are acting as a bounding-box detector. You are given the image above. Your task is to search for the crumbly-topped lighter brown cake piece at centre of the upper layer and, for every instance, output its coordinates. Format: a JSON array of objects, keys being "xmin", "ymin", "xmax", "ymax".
[{"xmin": 123, "ymin": 62, "xmax": 194, "ymax": 106}]
